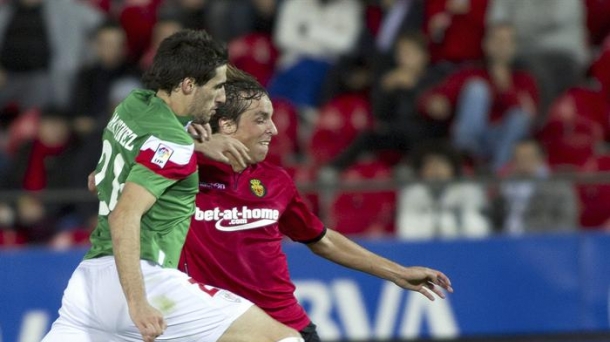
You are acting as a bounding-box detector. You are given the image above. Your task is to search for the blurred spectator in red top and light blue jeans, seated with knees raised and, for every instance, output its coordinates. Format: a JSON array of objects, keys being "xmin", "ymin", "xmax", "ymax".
[{"xmin": 420, "ymin": 23, "xmax": 538, "ymax": 171}]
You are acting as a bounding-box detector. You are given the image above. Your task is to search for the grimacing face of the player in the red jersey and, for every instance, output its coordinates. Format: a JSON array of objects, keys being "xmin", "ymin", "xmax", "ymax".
[{"xmin": 233, "ymin": 96, "xmax": 277, "ymax": 163}]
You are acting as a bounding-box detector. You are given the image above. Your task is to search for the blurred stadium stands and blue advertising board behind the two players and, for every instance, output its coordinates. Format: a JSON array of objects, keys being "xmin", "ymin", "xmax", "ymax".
[{"xmin": 0, "ymin": 0, "xmax": 610, "ymax": 342}]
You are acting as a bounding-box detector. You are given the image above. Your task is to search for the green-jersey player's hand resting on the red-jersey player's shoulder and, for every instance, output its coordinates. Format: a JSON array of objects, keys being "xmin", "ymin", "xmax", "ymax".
[{"xmin": 195, "ymin": 134, "xmax": 251, "ymax": 169}]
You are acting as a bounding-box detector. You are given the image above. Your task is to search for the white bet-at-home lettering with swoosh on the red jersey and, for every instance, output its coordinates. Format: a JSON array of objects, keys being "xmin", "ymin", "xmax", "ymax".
[{"xmin": 195, "ymin": 206, "xmax": 280, "ymax": 232}]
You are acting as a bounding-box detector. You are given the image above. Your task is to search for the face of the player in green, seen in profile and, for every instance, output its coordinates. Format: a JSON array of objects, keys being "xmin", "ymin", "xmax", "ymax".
[{"xmin": 189, "ymin": 65, "xmax": 227, "ymax": 124}]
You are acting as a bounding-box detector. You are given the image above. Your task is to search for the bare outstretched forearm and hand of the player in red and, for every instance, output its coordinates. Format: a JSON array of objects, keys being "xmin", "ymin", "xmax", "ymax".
[{"xmin": 308, "ymin": 229, "xmax": 453, "ymax": 300}]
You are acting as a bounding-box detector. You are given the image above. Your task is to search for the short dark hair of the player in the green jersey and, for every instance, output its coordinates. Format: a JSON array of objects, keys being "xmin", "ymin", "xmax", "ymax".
[{"xmin": 142, "ymin": 30, "xmax": 228, "ymax": 93}]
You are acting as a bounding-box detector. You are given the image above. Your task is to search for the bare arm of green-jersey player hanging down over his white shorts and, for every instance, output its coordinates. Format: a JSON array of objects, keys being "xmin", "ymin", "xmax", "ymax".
[{"xmin": 108, "ymin": 182, "xmax": 166, "ymax": 342}]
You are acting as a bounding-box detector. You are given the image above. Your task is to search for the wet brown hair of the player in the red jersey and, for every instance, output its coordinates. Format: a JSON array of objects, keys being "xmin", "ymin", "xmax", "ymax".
[{"xmin": 210, "ymin": 65, "xmax": 269, "ymax": 133}]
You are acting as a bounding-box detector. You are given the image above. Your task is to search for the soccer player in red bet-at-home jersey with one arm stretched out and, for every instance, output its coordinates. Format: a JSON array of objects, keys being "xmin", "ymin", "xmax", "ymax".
[{"xmin": 179, "ymin": 67, "xmax": 453, "ymax": 341}]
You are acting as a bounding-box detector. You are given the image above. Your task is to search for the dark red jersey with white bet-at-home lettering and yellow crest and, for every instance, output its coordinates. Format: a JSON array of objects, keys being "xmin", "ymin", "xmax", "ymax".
[{"xmin": 180, "ymin": 157, "xmax": 325, "ymax": 330}]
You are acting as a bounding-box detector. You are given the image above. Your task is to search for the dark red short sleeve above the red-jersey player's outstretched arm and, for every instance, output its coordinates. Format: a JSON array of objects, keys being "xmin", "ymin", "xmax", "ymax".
[{"xmin": 279, "ymin": 189, "xmax": 326, "ymax": 243}]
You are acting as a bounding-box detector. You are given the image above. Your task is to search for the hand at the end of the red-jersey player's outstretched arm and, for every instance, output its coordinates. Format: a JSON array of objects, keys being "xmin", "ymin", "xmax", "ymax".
[{"xmin": 394, "ymin": 267, "xmax": 453, "ymax": 300}]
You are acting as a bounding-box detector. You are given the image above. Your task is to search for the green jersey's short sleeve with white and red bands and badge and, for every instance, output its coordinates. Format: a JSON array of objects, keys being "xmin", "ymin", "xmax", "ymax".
[{"xmin": 127, "ymin": 135, "xmax": 197, "ymax": 198}]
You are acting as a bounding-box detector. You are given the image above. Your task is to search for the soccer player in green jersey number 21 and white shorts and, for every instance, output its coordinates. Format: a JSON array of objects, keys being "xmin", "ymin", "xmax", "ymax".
[{"xmin": 43, "ymin": 30, "xmax": 302, "ymax": 342}]
